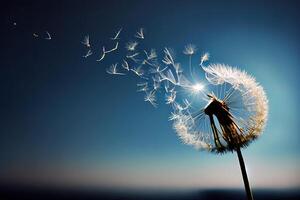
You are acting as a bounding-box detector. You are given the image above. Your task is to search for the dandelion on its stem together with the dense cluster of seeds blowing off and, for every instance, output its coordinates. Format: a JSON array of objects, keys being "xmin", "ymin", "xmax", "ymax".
[{"xmin": 99, "ymin": 29, "xmax": 268, "ymax": 199}]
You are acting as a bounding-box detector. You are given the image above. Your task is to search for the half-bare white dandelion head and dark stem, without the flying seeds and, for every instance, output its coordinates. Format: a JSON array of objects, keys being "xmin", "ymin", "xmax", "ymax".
[{"xmin": 173, "ymin": 64, "xmax": 268, "ymax": 199}]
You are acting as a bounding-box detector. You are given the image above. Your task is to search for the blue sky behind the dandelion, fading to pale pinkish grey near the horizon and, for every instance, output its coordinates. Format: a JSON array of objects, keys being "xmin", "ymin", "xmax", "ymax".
[{"xmin": 0, "ymin": 1, "xmax": 300, "ymax": 188}]
